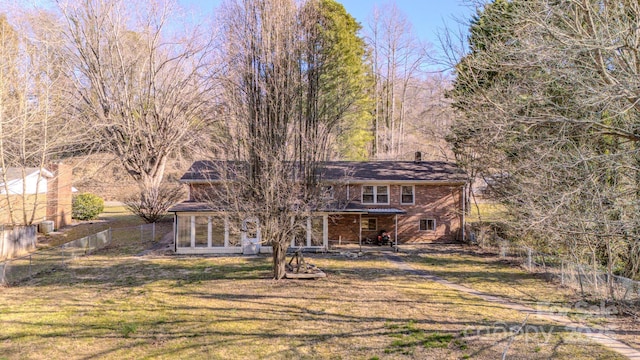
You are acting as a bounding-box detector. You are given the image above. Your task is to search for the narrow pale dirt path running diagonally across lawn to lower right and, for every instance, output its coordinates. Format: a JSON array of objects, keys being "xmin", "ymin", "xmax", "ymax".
[{"xmin": 384, "ymin": 254, "xmax": 640, "ymax": 360}]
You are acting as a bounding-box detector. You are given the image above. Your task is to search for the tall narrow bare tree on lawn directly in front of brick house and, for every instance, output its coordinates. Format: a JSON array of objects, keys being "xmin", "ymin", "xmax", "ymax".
[{"xmin": 215, "ymin": 0, "xmax": 312, "ymax": 279}]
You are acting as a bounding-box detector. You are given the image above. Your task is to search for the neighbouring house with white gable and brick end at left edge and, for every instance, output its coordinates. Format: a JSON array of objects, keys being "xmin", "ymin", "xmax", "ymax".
[{"xmin": 0, "ymin": 164, "xmax": 72, "ymax": 229}]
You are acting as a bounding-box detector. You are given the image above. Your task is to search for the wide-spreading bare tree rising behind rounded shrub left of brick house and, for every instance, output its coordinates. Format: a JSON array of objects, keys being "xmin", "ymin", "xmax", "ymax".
[{"xmin": 59, "ymin": 0, "xmax": 218, "ymax": 221}]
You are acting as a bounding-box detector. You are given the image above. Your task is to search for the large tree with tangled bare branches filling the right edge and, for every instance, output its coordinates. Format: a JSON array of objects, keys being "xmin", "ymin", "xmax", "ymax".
[{"xmin": 450, "ymin": 0, "xmax": 640, "ymax": 286}]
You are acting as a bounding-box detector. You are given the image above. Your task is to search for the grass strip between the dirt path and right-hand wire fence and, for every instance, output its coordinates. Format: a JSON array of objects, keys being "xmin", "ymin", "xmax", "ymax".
[{"xmin": 407, "ymin": 245, "xmax": 640, "ymax": 349}]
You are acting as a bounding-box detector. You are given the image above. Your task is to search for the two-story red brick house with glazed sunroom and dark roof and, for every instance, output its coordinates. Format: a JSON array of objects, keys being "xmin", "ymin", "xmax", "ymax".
[{"xmin": 169, "ymin": 156, "xmax": 467, "ymax": 254}]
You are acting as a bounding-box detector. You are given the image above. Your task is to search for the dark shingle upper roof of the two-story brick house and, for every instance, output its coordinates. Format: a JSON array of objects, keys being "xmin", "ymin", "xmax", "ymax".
[{"xmin": 180, "ymin": 161, "xmax": 468, "ymax": 183}]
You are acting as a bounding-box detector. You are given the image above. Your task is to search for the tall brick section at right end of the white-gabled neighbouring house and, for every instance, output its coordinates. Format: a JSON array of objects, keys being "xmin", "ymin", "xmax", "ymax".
[{"xmin": 47, "ymin": 163, "xmax": 73, "ymax": 229}]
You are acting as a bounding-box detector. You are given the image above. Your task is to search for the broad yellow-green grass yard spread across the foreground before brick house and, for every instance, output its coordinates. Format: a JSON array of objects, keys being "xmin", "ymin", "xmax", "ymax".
[{"xmin": 0, "ymin": 236, "xmax": 632, "ymax": 359}]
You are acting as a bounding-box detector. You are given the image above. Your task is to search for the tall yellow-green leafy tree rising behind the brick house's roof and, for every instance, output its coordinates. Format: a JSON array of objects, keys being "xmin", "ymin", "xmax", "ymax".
[{"xmin": 301, "ymin": 0, "xmax": 372, "ymax": 160}]
